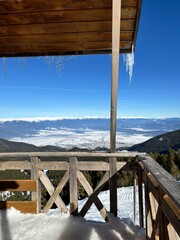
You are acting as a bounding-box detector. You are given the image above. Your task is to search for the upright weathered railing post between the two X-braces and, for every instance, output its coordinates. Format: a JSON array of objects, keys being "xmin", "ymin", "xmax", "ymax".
[{"xmin": 69, "ymin": 157, "xmax": 78, "ymax": 215}]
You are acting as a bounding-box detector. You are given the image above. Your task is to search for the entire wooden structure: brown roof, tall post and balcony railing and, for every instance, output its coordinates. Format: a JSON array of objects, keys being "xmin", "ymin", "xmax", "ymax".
[{"xmin": 0, "ymin": 0, "xmax": 180, "ymax": 240}]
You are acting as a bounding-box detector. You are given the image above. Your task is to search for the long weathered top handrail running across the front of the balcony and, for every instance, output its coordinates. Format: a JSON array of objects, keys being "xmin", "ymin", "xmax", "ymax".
[{"xmin": 0, "ymin": 152, "xmax": 141, "ymax": 158}]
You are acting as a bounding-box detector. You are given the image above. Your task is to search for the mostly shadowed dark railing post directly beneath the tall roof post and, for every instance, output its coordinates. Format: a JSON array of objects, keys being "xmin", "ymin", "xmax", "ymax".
[{"xmin": 109, "ymin": 157, "xmax": 117, "ymax": 216}]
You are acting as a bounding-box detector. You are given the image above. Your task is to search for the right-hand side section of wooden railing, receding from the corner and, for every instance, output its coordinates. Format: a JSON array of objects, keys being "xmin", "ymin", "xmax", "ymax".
[{"xmin": 138, "ymin": 155, "xmax": 180, "ymax": 240}]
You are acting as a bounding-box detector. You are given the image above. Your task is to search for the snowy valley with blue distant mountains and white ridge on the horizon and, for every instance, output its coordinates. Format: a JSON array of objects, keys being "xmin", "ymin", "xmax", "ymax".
[{"xmin": 0, "ymin": 118, "xmax": 180, "ymax": 149}]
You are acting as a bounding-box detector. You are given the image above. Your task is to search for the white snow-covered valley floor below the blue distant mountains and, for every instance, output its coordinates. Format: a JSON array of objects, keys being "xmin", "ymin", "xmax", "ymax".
[{"xmin": 10, "ymin": 128, "xmax": 151, "ymax": 149}]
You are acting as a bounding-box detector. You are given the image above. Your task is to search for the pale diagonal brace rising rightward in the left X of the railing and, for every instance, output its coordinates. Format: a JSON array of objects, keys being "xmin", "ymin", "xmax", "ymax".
[{"xmin": 42, "ymin": 171, "xmax": 69, "ymax": 213}]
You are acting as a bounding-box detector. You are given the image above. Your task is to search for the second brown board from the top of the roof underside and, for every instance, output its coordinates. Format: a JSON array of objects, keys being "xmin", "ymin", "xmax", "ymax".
[{"xmin": 0, "ymin": 7, "xmax": 136, "ymax": 26}]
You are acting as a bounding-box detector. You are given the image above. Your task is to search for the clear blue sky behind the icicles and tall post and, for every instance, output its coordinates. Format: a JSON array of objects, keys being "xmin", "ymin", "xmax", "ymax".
[{"xmin": 0, "ymin": 0, "xmax": 180, "ymax": 118}]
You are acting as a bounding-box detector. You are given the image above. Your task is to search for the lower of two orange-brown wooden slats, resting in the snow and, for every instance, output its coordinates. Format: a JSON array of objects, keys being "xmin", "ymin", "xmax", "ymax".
[{"xmin": 0, "ymin": 201, "xmax": 37, "ymax": 213}]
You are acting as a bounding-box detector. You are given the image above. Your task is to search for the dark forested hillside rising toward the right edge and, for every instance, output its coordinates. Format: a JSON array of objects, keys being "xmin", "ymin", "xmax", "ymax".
[{"xmin": 128, "ymin": 129, "xmax": 180, "ymax": 153}]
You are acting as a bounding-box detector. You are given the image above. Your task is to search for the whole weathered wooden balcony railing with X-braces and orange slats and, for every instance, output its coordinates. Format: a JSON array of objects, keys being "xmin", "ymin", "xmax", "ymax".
[{"xmin": 0, "ymin": 152, "xmax": 180, "ymax": 240}]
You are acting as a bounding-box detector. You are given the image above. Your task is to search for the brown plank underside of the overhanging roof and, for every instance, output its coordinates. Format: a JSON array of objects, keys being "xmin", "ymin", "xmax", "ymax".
[{"xmin": 0, "ymin": 0, "xmax": 142, "ymax": 57}]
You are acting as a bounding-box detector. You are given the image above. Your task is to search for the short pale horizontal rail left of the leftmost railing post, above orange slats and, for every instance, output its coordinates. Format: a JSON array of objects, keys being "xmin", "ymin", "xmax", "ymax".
[{"xmin": 0, "ymin": 161, "xmax": 31, "ymax": 170}]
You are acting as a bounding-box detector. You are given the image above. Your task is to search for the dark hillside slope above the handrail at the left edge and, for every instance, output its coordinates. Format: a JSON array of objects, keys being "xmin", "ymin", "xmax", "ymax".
[{"xmin": 0, "ymin": 138, "xmax": 65, "ymax": 152}]
